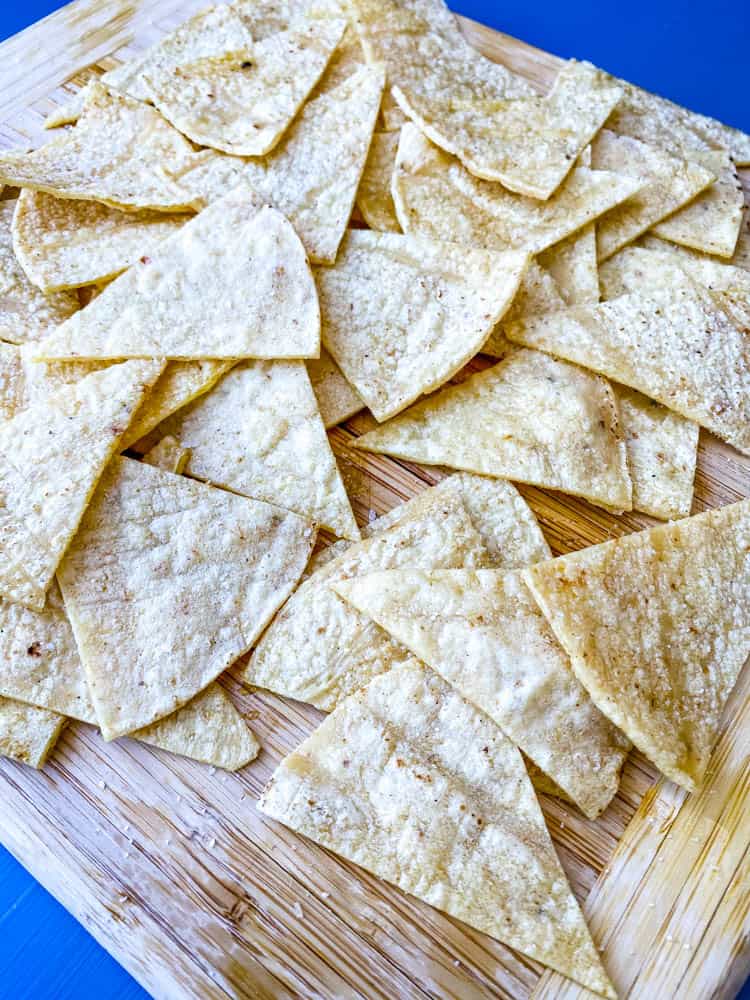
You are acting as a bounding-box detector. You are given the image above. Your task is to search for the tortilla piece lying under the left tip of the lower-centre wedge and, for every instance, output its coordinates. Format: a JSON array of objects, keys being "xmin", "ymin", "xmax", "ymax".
[{"xmin": 240, "ymin": 490, "xmax": 487, "ymax": 711}]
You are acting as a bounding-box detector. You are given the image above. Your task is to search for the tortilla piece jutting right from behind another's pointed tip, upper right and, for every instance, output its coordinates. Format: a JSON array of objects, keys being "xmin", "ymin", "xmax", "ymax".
[{"xmin": 591, "ymin": 129, "xmax": 716, "ymax": 261}]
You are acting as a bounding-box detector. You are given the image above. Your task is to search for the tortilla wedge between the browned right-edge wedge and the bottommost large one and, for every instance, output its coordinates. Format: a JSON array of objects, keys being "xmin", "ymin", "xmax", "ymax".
[{"xmin": 332, "ymin": 568, "xmax": 630, "ymax": 819}]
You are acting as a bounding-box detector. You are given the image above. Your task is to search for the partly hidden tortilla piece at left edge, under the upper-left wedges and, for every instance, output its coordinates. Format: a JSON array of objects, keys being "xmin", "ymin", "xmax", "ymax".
[{"xmin": 0, "ymin": 201, "xmax": 79, "ymax": 344}]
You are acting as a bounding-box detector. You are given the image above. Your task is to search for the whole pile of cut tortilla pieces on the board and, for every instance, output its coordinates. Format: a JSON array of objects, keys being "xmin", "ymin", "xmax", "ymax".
[{"xmin": 0, "ymin": 0, "xmax": 750, "ymax": 997}]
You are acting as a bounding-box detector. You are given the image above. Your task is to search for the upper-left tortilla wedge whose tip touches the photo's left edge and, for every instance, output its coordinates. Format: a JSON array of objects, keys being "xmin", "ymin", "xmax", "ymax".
[{"xmin": 0, "ymin": 83, "xmax": 194, "ymax": 212}]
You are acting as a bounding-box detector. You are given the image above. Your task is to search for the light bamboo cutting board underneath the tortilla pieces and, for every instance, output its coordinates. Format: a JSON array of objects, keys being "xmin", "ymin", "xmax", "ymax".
[{"xmin": 0, "ymin": 0, "xmax": 750, "ymax": 1000}]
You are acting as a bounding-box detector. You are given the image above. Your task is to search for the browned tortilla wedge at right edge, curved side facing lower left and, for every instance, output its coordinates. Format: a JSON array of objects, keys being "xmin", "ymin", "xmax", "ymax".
[{"xmin": 526, "ymin": 500, "xmax": 750, "ymax": 791}]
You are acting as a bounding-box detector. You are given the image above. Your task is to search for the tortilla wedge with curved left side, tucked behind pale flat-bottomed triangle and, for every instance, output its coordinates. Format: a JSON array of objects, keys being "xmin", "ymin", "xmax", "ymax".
[{"xmin": 13, "ymin": 191, "xmax": 189, "ymax": 292}]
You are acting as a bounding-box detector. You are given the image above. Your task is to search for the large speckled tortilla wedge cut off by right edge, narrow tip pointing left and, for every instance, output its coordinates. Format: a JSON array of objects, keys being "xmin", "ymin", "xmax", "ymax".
[{"xmin": 504, "ymin": 275, "xmax": 750, "ymax": 454}]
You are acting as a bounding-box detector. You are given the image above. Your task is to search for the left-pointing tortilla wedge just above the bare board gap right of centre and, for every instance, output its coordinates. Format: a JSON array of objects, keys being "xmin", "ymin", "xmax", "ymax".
[{"xmin": 353, "ymin": 351, "xmax": 632, "ymax": 510}]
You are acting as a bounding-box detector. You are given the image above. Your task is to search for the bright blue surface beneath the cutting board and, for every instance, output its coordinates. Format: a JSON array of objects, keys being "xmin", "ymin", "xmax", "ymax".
[{"xmin": 0, "ymin": 0, "xmax": 750, "ymax": 1000}]
